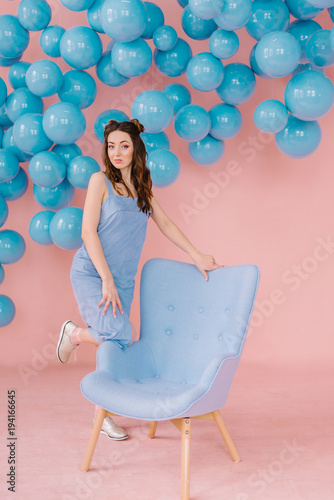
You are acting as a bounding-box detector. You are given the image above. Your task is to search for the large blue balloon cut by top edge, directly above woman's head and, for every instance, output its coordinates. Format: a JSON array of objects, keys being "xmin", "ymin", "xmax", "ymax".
[{"xmin": 101, "ymin": 0, "xmax": 147, "ymax": 42}]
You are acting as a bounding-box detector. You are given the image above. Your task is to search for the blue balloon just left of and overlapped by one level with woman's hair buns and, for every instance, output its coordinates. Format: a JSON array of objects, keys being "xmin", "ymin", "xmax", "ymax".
[{"xmin": 13, "ymin": 113, "xmax": 53, "ymax": 154}]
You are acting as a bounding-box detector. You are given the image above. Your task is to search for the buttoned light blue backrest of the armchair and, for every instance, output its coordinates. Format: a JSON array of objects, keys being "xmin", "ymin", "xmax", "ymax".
[{"xmin": 140, "ymin": 259, "xmax": 259, "ymax": 383}]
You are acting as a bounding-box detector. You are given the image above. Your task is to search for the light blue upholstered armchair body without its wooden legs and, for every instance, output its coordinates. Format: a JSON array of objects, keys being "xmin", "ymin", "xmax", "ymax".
[{"xmin": 81, "ymin": 259, "xmax": 259, "ymax": 420}]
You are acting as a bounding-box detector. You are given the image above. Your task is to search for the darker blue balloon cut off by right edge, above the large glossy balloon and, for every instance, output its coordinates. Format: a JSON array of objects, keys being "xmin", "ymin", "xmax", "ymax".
[{"xmin": 305, "ymin": 30, "xmax": 334, "ymax": 68}]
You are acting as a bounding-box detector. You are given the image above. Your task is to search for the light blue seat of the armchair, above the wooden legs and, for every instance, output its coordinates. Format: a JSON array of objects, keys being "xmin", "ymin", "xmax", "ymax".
[{"xmin": 81, "ymin": 371, "xmax": 207, "ymax": 420}]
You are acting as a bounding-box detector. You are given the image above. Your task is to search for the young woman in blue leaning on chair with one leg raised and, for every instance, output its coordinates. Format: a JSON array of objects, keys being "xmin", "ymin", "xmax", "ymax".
[{"xmin": 57, "ymin": 120, "xmax": 220, "ymax": 439}]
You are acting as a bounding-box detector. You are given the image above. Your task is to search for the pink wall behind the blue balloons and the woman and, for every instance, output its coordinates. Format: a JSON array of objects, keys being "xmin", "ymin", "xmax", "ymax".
[{"xmin": 0, "ymin": 0, "xmax": 334, "ymax": 376}]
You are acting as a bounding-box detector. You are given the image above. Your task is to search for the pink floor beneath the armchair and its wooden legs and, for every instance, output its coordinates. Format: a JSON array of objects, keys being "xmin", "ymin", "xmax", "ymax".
[{"xmin": 0, "ymin": 359, "xmax": 334, "ymax": 500}]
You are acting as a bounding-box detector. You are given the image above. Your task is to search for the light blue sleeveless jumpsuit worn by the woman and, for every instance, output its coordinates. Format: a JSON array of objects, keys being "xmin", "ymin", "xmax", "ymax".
[{"xmin": 70, "ymin": 176, "xmax": 150, "ymax": 348}]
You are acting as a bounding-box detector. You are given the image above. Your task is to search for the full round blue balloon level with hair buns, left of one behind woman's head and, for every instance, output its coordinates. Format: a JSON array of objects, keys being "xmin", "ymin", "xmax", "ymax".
[{"xmin": 43, "ymin": 102, "xmax": 86, "ymax": 144}]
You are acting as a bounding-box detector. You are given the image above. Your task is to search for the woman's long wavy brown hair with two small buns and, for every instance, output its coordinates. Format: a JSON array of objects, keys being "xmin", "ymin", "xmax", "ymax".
[{"xmin": 102, "ymin": 119, "xmax": 153, "ymax": 214}]
